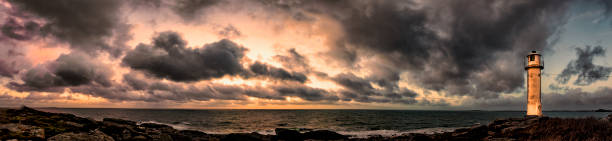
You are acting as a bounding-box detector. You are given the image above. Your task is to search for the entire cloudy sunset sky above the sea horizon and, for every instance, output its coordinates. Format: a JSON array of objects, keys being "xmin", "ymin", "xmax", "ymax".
[{"xmin": 0, "ymin": 0, "xmax": 612, "ymax": 111}]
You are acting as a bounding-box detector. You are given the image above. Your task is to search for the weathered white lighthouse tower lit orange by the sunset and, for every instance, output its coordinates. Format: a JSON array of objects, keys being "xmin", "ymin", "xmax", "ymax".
[{"xmin": 525, "ymin": 51, "xmax": 544, "ymax": 117}]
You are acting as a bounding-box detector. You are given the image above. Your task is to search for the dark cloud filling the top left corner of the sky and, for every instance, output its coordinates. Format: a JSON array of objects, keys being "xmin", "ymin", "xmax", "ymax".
[{"xmin": 3, "ymin": 0, "xmax": 127, "ymax": 56}]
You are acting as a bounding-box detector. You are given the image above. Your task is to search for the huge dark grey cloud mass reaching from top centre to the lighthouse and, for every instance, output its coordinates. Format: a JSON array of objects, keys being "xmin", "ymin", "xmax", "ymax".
[{"xmin": 276, "ymin": 0, "xmax": 566, "ymax": 98}]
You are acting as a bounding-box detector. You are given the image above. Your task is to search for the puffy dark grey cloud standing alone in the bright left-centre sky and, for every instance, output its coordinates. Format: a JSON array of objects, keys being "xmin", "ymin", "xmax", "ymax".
[{"xmin": 123, "ymin": 32, "xmax": 246, "ymax": 81}]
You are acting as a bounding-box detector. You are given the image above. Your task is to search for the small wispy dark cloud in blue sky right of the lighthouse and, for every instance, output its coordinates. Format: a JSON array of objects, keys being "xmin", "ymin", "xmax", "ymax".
[{"xmin": 555, "ymin": 45, "xmax": 612, "ymax": 86}]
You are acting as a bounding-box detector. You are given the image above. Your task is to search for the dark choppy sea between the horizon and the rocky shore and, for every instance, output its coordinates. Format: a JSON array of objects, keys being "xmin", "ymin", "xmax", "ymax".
[{"xmin": 37, "ymin": 108, "xmax": 612, "ymax": 138}]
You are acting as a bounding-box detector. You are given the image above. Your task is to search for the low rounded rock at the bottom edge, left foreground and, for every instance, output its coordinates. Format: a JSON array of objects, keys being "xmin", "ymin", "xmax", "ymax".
[{"xmin": 47, "ymin": 130, "xmax": 114, "ymax": 141}]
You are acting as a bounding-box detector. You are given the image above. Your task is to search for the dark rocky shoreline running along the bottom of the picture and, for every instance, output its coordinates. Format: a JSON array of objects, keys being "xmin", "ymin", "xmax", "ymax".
[{"xmin": 0, "ymin": 107, "xmax": 612, "ymax": 141}]
